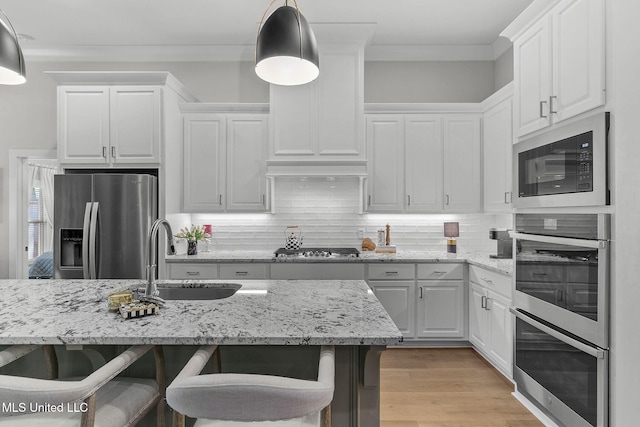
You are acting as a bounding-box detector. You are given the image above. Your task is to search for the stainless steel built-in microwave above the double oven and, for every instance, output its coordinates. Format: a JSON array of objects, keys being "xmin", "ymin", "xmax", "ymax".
[{"xmin": 513, "ymin": 112, "xmax": 609, "ymax": 208}]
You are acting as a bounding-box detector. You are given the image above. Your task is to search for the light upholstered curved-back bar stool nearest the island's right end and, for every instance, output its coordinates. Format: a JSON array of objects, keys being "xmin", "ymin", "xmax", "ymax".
[{"xmin": 167, "ymin": 346, "xmax": 335, "ymax": 427}]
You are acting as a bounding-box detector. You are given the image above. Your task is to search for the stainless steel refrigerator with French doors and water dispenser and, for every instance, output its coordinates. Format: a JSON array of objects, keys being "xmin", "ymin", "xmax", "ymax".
[{"xmin": 53, "ymin": 173, "xmax": 158, "ymax": 279}]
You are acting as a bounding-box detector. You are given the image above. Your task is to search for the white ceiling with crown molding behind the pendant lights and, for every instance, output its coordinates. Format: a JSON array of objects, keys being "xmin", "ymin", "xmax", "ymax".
[{"xmin": 0, "ymin": 0, "xmax": 532, "ymax": 61}]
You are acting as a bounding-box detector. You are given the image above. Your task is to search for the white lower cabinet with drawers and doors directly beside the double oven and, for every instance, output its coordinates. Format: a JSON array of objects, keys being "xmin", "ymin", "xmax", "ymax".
[{"xmin": 469, "ymin": 266, "xmax": 513, "ymax": 378}]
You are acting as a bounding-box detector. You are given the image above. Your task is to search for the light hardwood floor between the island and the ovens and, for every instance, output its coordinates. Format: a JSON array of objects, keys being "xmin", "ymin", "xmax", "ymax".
[{"xmin": 380, "ymin": 348, "xmax": 542, "ymax": 427}]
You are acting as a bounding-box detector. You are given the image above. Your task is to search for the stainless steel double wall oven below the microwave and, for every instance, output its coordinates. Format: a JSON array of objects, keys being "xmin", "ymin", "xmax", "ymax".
[{"xmin": 511, "ymin": 214, "xmax": 610, "ymax": 427}]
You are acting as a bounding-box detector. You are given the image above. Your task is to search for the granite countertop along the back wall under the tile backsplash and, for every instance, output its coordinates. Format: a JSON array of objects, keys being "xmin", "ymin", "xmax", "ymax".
[{"xmin": 166, "ymin": 250, "xmax": 513, "ymax": 276}]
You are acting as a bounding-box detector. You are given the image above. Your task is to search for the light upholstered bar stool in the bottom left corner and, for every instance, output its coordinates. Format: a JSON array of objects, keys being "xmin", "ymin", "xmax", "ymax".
[{"xmin": 0, "ymin": 345, "xmax": 166, "ymax": 427}]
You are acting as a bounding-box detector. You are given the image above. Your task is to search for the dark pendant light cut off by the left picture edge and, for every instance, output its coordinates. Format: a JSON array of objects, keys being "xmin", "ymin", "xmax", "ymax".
[{"xmin": 0, "ymin": 10, "xmax": 27, "ymax": 85}]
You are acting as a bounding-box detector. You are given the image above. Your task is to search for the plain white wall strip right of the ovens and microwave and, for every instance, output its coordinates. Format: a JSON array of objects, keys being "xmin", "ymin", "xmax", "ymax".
[{"xmin": 607, "ymin": 0, "xmax": 640, "ymax": 427}]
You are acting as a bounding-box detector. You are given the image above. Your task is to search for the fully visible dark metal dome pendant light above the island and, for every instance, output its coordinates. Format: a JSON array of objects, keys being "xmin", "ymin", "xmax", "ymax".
[{"xmin": 256, "ymin": 0, "xmax": 320, "ymax": 86}]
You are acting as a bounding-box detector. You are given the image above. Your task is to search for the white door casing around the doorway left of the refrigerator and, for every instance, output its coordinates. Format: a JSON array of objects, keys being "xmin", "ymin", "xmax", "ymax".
[{"xmin": 9, "ymin": 150, "xmax": 58, "ymax": 279}]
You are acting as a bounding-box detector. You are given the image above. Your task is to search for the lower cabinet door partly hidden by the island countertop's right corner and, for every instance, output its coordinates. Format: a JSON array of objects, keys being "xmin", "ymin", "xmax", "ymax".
[{"xmin": 369, "ymin": 280, "xmax": 415, "ymax": 338}]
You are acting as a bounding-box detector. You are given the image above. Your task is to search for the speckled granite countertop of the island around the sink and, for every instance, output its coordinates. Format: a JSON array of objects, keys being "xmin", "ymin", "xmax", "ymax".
[{"xmin": 0, "ymin": 280, "xmax": 402, "ymax": 345}]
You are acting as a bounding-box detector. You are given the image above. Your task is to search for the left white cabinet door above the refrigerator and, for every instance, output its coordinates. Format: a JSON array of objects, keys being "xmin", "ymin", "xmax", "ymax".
[{"xmin": 58, "ymin": 86, "xmax": 109, "ymax": 164}]
